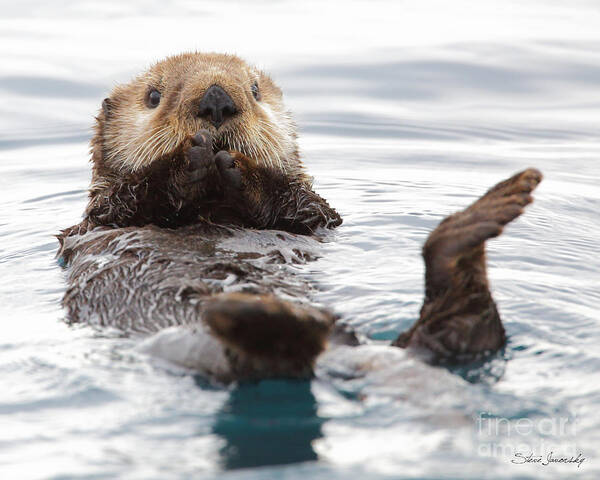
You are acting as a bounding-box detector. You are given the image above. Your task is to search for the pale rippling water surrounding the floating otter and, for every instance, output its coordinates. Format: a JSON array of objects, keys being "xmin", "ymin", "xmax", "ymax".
[{"xmin": 0, "ymin": 0, "xmax": 600, "ymax": 479}]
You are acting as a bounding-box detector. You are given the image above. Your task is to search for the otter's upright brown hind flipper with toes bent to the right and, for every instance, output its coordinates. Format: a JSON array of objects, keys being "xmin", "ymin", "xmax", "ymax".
[{"xmin": 394, "ymin": 168, "xmax": 542, "ymax": 361}]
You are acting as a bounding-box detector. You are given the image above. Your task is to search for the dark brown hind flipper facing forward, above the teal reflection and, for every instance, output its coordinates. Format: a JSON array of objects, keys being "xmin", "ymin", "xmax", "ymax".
[{"xmin": 202, "ymin": 293, "xmax": 335, "ymax": 378}]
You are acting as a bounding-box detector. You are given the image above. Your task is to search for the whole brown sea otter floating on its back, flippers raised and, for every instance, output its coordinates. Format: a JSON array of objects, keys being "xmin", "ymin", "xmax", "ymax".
[{"xmin": 59, "ymin": 53, "xmax": 541, "ymax": 382}]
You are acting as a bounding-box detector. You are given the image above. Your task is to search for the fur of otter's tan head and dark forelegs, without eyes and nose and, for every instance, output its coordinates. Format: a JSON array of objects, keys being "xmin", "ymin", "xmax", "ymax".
[{"xmin": 59, "ymin": 53, "xmax": 341, "ymax": 240}]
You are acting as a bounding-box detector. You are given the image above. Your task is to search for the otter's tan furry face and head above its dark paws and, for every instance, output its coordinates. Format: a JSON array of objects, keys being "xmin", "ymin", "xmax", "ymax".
[{"xmin": 98, "ymin": 53, "xmax": 298, "ymax": 172}]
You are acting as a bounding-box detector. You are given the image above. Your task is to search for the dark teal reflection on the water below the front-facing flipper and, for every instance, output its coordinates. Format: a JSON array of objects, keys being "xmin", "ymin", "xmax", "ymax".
[{"xmin": 213, "ymin": 380, "xmax": 324, "ymax": 470}]
